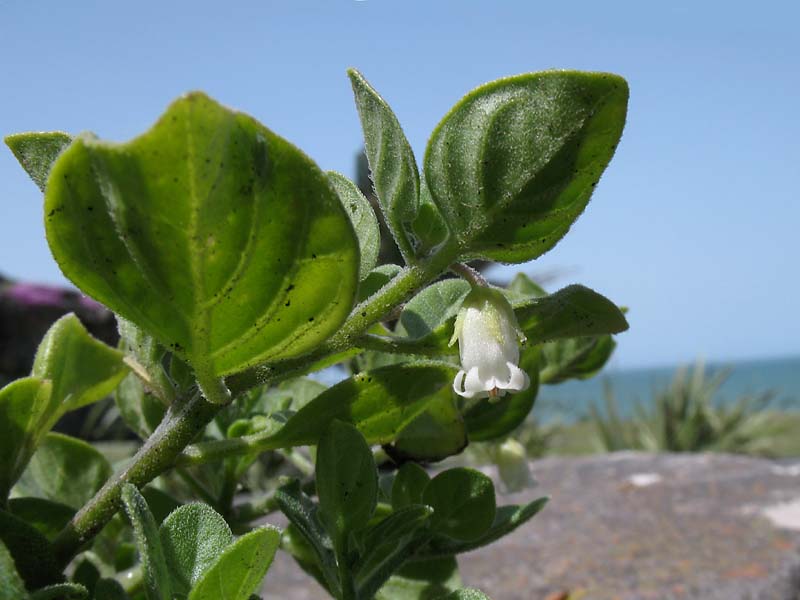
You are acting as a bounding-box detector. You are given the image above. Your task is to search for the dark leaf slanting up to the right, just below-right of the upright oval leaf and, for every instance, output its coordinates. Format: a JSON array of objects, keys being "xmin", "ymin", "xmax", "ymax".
[{"xmin": 356, "ymin": 505, "xmax": 433, "ymax": 598}]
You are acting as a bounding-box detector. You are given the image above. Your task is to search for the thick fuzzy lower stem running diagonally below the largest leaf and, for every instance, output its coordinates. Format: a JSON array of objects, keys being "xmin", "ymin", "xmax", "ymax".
[{"xmin": 53, "ymin": 394, "xmax": 220, "ymax": 565}]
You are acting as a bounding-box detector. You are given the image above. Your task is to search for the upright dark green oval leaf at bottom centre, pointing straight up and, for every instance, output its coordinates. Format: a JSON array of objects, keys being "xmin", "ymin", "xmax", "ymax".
[{"xmin": 316, "ymin": 420, "xmax": 378, "ymax": 552}]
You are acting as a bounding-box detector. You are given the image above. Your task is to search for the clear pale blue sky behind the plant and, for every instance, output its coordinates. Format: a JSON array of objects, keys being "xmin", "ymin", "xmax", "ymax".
[{"xmin": 0, "ymin": 0, "xmax": 800, "ymax": 367}]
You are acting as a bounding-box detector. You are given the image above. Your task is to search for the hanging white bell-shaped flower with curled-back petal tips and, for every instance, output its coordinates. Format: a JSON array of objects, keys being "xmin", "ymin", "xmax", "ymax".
[{"xmin": 450, "ymin": 287, "xmax": 530, "ymax": 400}]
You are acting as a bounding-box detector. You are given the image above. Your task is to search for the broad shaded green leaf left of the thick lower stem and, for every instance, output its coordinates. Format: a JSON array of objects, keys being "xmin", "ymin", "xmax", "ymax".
[{"xmin": 14, "ymin": 433, "xmax": 112, "ymax": 510}]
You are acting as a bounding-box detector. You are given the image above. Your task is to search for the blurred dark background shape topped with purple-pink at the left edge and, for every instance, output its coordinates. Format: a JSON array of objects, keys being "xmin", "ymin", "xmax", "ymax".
[{"xmin": 0, "ymin": 275, "xmax": 119, "ymax": 381}]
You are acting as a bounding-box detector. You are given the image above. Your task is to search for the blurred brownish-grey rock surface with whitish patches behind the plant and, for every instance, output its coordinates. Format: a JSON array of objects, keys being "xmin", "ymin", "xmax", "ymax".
[{"xmin": 265, "ymin": 453, "xmax": 800, "ymax": 600}]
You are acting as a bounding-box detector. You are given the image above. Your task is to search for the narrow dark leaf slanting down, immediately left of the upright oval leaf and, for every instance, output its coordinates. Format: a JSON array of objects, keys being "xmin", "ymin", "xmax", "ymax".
[{"xmin": 275, "ymin": 479, "xmax": 339, "ymax": 593}]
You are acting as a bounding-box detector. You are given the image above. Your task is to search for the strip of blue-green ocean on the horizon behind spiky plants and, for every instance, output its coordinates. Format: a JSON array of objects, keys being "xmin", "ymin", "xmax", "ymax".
[{"xmin": 533, "ymin": 356, "xmax": 800, "ymax": 423}]
